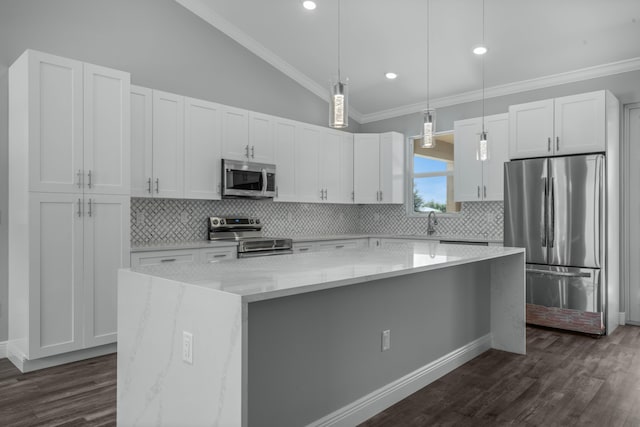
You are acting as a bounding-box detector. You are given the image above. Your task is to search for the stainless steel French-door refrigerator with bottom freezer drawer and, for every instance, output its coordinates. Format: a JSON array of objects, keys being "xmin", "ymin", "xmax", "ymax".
[{"xmin": 504, "ymin": 154, "xmax": 607, "ymax": 334}]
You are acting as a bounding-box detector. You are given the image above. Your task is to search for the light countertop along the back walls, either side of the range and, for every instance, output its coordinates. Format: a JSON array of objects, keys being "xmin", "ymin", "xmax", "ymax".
[{"xmin": 131, "ymin": 233, "xmax": 502, "ymax": 252}]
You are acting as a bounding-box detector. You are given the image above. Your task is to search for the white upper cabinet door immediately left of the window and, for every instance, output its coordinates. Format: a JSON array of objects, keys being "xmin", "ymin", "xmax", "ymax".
[{"xmin": 379, "ymin": 132, "xmax": 405, "ymax": 203}]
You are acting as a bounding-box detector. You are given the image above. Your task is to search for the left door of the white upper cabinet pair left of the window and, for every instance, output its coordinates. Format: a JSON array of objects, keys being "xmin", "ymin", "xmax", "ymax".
[{"xmin": 353, "ymin": 133, "xmax": 380, "ymax": 203}]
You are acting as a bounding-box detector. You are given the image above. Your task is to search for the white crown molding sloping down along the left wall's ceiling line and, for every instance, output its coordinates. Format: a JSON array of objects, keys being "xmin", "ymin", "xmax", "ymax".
[{"xmin": 175, "ymin": 0, "xmax": 363, "ymax": 123}]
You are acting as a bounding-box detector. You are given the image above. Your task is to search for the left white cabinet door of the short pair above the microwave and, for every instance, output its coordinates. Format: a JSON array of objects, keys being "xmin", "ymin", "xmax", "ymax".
[{"xmin": 222, "ymin": 105, "xmax": 250, "ymax": 160}]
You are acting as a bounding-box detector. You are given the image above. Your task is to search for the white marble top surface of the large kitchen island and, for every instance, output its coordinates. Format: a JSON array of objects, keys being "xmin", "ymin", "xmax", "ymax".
[{"xmin": 127, "ymin": 241, "xmax": 524, "ymax": 303}]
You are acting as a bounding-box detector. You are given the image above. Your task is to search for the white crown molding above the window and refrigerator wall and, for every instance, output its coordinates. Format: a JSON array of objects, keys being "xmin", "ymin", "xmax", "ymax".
[{"xmin": 360, "ymin": 57, "xmax": 640, "ymax": 124}]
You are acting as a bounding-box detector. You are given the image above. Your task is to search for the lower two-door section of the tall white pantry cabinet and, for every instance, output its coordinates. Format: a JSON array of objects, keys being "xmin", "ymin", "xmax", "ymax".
[{"xmin": 9, "ymin": 193, "xmax": 130, "ymax": 360}]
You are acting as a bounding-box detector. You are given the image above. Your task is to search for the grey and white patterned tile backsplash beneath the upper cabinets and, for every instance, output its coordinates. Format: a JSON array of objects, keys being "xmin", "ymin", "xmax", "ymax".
[{"xmin": 131, "ymin": 197, "xmax": 503, "ymax": 246}]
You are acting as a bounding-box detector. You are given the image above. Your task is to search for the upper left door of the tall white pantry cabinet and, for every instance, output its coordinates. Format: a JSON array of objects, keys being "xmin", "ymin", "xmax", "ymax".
[{"xmin": 26, "ymin": 51, "xmax": 83, "ymax": 193}]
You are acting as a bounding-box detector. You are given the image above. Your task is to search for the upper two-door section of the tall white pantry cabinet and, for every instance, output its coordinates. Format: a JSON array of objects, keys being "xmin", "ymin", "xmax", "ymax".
[{"xmin": 11, "ymin": 51, "xmax": 130, "ymax": 194}]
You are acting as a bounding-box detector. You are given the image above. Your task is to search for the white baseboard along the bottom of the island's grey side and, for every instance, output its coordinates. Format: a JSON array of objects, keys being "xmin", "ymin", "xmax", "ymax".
[{"xmin": 308, "ymin": 334, "xmax": 491, "ymax": 427}]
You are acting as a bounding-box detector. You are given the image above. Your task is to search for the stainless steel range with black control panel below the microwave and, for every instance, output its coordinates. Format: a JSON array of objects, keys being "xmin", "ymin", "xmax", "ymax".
[{"xmin": 209, "ymin": 216, "xmax": 293, "ymax": 258}]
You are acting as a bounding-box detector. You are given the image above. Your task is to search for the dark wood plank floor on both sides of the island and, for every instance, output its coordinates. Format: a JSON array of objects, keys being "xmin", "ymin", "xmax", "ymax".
[{"xmin": 0, "ymin": 326, "xmax": 640, "ymax": 427}]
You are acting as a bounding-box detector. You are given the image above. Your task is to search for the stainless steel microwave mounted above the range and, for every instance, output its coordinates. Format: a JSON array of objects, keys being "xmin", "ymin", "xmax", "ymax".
[{"xmin": 222, "ymin": 159, "xmax": 276, "ymax": 199}]
